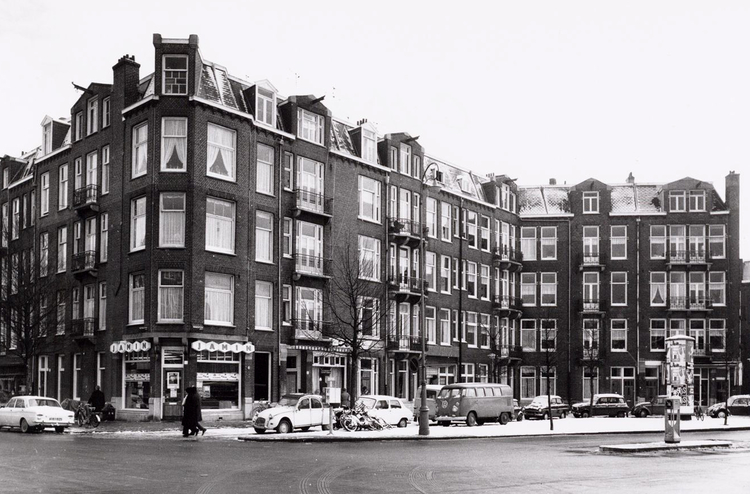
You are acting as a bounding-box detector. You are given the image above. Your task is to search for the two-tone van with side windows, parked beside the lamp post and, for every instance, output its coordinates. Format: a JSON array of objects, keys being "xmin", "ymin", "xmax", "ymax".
[{"xmin": 435, "ymin": 383, "xmax": 513, "ymax": 427}]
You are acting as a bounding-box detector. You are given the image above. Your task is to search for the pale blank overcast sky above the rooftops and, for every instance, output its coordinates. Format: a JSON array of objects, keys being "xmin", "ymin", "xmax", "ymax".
[{"xmin": 0, "ymin": 0, "xmax": 750, "ymax": 260}]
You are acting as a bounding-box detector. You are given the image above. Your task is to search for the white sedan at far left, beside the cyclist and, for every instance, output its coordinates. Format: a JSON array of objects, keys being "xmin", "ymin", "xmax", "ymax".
[{"xmin": 0, "ymin": 396, "xmax": 74, "ymax": 432}]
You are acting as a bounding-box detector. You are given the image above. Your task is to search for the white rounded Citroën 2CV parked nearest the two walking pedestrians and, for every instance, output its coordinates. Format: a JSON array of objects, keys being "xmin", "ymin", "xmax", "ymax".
[{"xmin": 253, "ymin": 393, "xmax": 331, "ymax": 434}]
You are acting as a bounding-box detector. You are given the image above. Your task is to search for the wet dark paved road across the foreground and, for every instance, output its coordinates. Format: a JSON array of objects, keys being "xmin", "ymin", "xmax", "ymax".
[{"xmin": 0, "ymin": 431, "xmax": 750, "ymax": 494}]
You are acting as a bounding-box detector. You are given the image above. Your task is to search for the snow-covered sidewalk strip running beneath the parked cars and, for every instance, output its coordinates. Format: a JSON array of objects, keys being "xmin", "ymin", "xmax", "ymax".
[{"xmin": 75, "ymin": 417, "xmax": 750, "ymax": 442}]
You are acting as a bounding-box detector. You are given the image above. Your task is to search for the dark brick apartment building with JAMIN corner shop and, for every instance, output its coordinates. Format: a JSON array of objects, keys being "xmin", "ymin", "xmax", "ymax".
[{"xmin": 0, "ymin": 34, "xmax": 742, "ymax": 420}]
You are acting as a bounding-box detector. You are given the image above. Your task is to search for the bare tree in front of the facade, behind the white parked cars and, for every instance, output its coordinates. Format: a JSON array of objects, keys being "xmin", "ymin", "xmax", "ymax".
[{"xmin": 322, "ymin": 242, "xmax": 388, "ymax": 404}]
